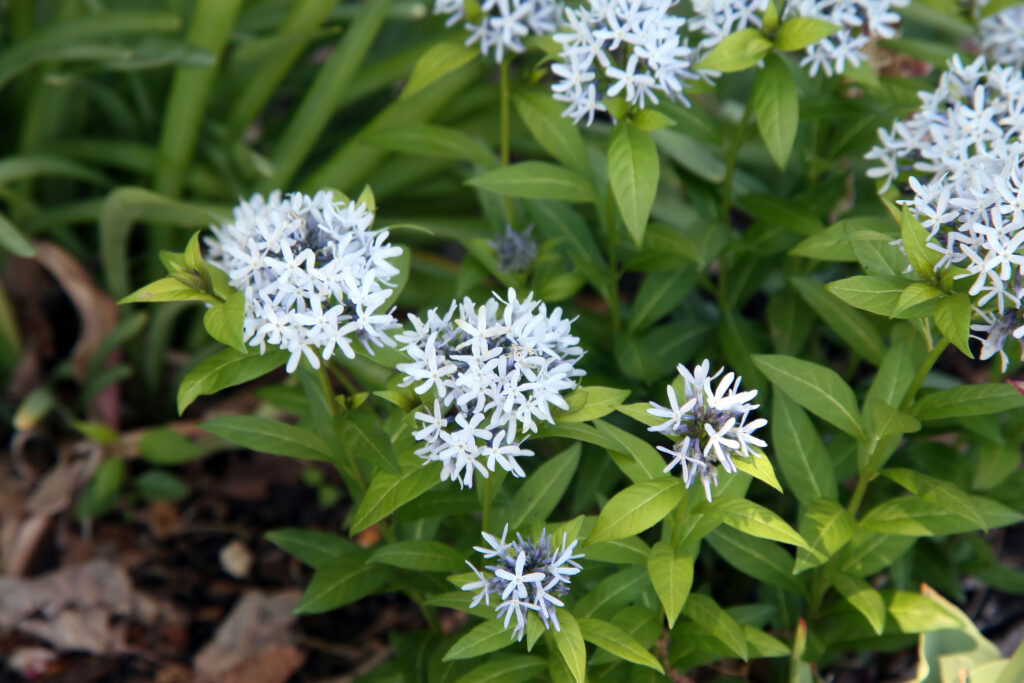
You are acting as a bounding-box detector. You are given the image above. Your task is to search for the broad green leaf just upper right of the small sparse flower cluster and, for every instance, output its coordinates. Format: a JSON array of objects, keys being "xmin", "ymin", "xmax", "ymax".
[{"xmin": 754, "ymin": 355, "xmax": 864, "ymax": 440}]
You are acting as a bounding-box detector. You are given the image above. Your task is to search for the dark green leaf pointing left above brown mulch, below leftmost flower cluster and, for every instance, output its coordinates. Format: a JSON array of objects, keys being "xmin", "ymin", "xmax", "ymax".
[{"xmin": 200, "ymin": 415, "xmax": 331, "ymax": 462}]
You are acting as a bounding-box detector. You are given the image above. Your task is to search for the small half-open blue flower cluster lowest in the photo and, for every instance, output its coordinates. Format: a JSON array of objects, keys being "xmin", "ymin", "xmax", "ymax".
[{"xmin": 462, "ymin": 524, "xmax": 583, "ymax": 640}]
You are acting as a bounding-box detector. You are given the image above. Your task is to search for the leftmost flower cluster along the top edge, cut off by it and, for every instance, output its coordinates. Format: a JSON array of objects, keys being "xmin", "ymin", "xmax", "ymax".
[{"xmin": 434, "ymin": 0, "xmax": 561, "ymax": 63}]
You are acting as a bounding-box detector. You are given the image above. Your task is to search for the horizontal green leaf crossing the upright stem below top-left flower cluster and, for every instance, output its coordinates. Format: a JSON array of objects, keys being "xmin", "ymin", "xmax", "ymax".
[{"xmin": 466, "ymin": 161, "xmax": 596, "ymax": 204}]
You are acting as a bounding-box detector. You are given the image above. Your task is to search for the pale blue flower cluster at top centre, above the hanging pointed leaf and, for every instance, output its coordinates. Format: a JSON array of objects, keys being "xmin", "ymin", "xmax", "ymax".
[{"xmin": 551, "ymin": 0, "xmax": 697, "ymax": 125}]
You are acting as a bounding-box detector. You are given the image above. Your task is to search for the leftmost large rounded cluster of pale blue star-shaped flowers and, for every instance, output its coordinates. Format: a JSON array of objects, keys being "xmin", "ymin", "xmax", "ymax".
[{"xmin": 206, "ymin": 190, "xmax": 401, "ymax": 373}]
